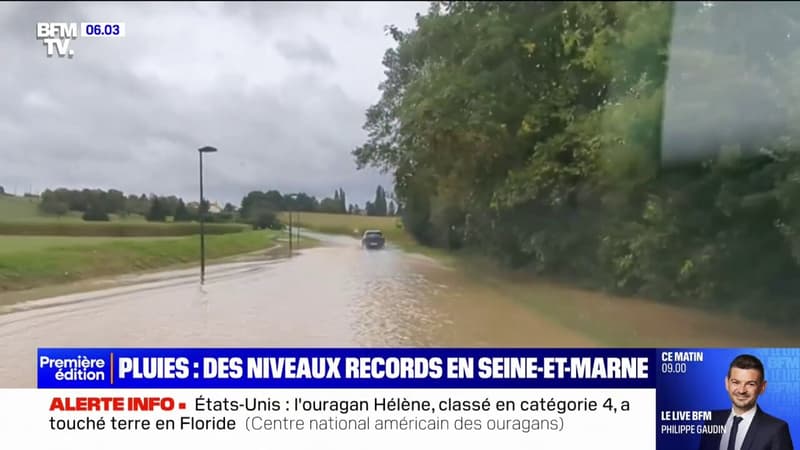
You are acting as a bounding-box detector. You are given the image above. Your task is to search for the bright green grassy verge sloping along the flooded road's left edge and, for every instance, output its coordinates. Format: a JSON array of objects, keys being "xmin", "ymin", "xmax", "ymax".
[{"xmin": 0, "ymin": 231, "xmax": 300, "ymax": 292}]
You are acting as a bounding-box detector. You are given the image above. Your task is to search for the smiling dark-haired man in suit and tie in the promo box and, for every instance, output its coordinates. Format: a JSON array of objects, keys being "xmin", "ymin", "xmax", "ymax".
[{"xmin": 700, "ymin": 355, "xmax": 794, "ymax": 450}]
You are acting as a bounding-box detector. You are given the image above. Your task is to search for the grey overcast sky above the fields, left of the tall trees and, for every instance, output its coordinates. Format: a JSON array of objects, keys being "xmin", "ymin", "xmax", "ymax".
[{"xmin": 0, "ymin": 2, "xmax": 427, "ymax": 206}]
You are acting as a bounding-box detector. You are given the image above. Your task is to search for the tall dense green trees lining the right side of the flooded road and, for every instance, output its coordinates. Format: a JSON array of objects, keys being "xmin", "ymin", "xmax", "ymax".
[{"xmin": 353, "ymin": 1, "xmax": 800, "ymax": 326}]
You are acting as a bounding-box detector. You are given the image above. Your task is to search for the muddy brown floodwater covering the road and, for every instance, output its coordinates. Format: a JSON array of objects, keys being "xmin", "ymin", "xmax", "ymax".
[{"xmin": 0, "ymin": 235, "xmax": 800, "ymax": 388}]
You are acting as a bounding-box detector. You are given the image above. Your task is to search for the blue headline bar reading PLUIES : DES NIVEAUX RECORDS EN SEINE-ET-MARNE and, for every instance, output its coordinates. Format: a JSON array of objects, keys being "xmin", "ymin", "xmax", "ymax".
[{"xmin": 36, "ymin": 348, "xmax": 658, "ymax": 389}]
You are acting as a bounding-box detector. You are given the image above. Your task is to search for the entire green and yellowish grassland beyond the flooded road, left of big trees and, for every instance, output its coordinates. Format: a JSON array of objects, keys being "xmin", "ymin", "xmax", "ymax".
[{"xmin": 0, "ymin": 195, "xmax": 422, "ymax": 292}]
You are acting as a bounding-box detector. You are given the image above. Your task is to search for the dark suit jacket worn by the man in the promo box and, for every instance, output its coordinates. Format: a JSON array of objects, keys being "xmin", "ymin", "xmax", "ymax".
[{"xmin": 700, "ymin": 407, "xmax": 794, "ymax": 450}]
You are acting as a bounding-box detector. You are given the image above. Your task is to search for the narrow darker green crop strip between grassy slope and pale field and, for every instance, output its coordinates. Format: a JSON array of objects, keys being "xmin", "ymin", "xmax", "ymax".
[{"xmin": 0, "ymin": 220, "xmax": 250, "ymax": 237}]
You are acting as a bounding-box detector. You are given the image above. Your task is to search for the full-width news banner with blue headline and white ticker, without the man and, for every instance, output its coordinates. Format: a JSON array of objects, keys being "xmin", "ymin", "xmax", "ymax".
[{"xmin": 0, "ymin": 348, "xmax": 800, "ymax": 450}]
